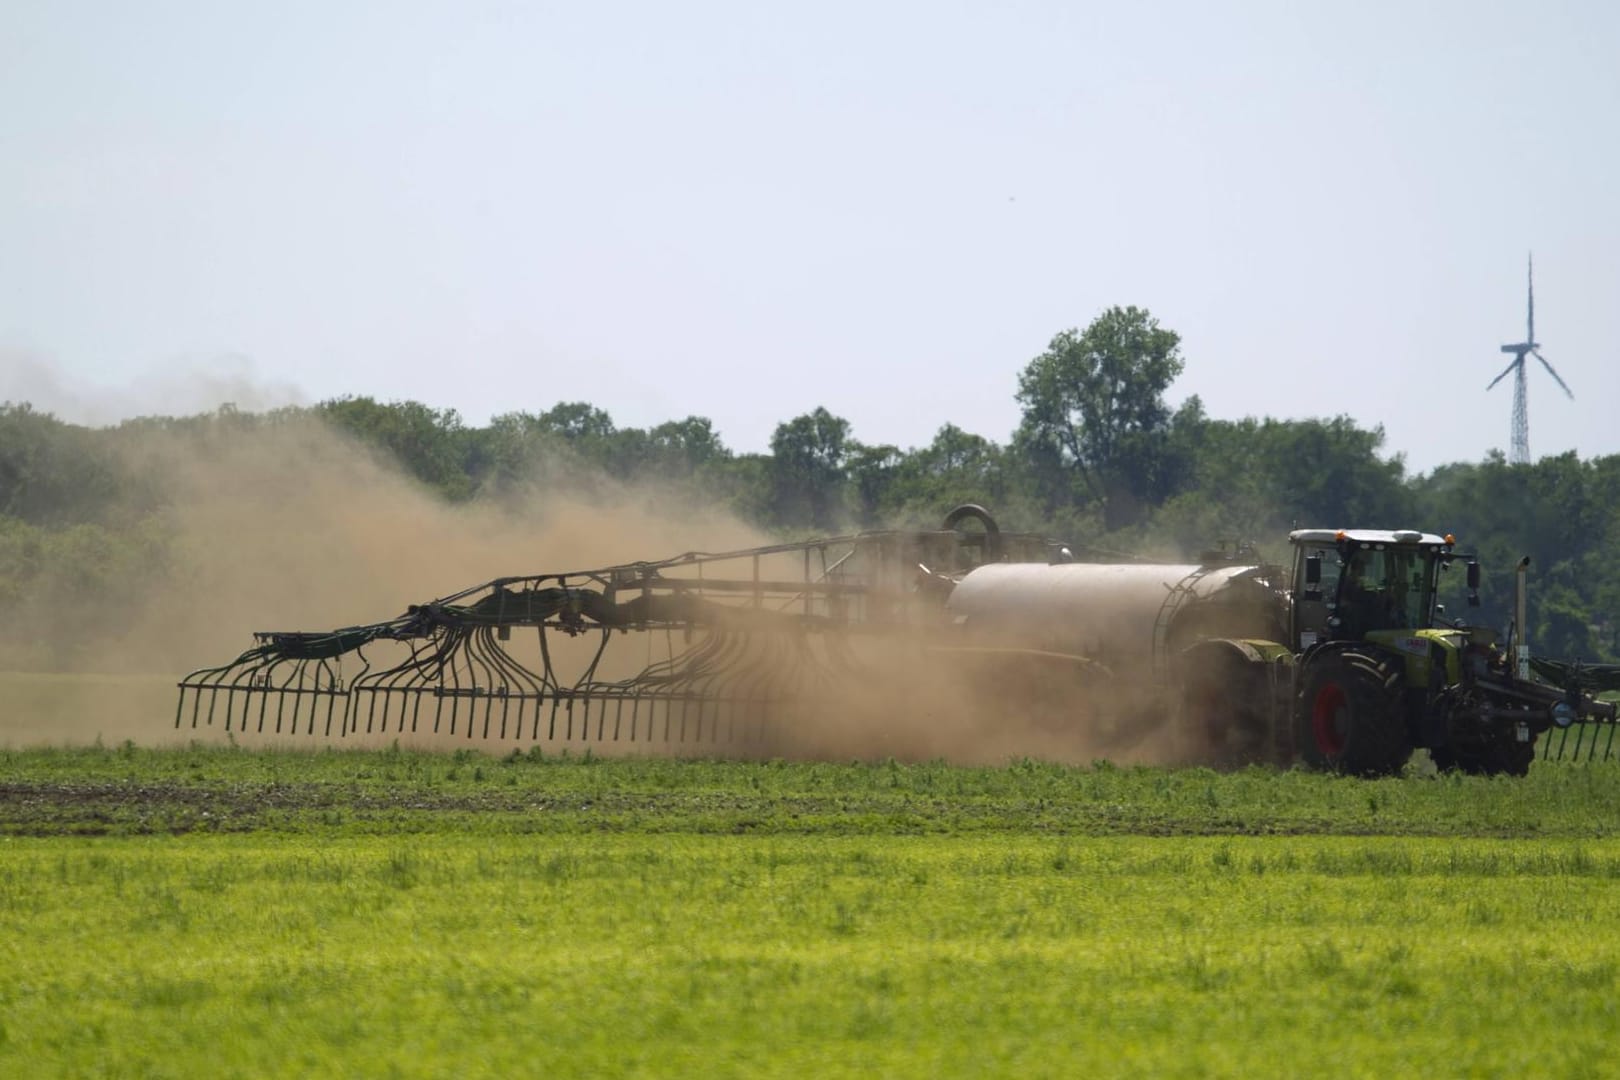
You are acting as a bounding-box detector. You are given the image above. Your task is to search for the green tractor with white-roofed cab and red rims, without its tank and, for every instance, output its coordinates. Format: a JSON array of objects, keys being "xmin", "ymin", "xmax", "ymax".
[{"xmin": 1286, "ymin": 529, "xmax": 1615, "ymax": 776}]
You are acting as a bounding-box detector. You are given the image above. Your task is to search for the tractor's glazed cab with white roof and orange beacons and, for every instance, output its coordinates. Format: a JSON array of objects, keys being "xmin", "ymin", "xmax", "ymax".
[{"xmin": 1288, "ymin": 529, "xmax": 1479, "ymax": 653}]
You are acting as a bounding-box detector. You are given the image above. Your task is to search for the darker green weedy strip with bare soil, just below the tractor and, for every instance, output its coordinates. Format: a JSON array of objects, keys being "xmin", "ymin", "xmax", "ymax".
[{"xmin": 0, "ymin": 745, "xmax": 1620, "ymax": 837}]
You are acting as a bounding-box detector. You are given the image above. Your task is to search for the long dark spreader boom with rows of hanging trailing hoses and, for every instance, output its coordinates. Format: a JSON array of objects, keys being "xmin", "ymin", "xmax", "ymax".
[{"xmin": 175, "ymin": 507, "xmax": 1056, "ymax": 743}]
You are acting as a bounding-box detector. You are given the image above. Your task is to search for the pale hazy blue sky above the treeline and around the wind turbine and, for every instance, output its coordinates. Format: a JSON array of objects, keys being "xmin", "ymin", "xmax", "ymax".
[{"xmin": 0, "ymin": 0, "xmax": 1620, "ymax": 473}]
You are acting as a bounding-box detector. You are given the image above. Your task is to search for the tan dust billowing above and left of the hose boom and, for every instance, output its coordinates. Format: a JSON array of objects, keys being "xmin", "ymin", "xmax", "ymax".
[{"xmin": 0, "ymin": 418, "xmax": 765, "ymax": 745}]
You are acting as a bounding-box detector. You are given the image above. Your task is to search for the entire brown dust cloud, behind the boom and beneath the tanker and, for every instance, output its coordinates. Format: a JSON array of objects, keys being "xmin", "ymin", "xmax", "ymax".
[{"xmin": 0, "ymin": 409, "xmax": 1168, "ymax": 764}]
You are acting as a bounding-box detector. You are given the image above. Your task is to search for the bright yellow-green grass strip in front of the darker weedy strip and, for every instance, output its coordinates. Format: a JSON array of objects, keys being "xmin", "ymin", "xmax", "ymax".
[{"xmin": 0, "ymin": 834, "xmax": 1620, "ymax": 1077}]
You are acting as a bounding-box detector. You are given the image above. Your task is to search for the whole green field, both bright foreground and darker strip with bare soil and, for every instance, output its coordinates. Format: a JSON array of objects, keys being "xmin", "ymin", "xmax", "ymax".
[{"xmin": 0, "ymin": 746, "xmax": 1620, "ymax": 1077}]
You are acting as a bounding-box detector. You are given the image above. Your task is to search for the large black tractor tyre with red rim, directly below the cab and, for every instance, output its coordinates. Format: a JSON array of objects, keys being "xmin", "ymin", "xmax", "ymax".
[{"xmin": 1294, "ymin": 653, "xmax": 1413, "ymax": 776}]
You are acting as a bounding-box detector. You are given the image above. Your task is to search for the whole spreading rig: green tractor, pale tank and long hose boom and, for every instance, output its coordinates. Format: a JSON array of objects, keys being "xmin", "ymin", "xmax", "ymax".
[{"xmin": 175, "ymin": 505, "xmax": 1620, "ymax": 776}]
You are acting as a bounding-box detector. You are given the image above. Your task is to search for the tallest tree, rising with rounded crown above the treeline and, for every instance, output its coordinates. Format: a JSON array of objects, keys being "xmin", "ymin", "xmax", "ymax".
[{"xmin": 1017, "ymin": 308, "xmax": 1183, "ymax": 529}]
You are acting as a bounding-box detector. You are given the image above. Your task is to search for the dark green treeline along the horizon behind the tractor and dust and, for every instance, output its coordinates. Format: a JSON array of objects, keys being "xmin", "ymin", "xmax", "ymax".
[{"xmin": 0, "ymin": 308, "xmax": 1620, "ymax": 661}]
